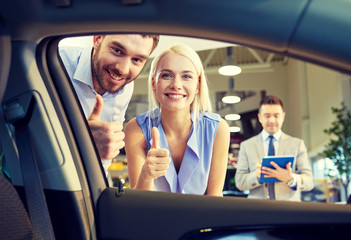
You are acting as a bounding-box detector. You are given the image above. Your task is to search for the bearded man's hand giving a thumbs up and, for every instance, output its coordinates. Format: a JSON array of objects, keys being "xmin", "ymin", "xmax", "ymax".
[{"xmin": 88, "ymin": 95, "xmax": 124, "ymax": 160}]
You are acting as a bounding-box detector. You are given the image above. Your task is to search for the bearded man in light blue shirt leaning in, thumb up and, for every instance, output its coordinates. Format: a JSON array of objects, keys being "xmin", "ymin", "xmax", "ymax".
[{"xmin": 59, "ymin": 34, "xmax": 159, "ymax": 172}]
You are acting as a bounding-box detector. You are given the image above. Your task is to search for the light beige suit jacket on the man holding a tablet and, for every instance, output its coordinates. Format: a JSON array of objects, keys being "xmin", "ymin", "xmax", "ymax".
[{"xmin": 235, "ymin": 132, "xmax": 314, "ymax": 201}]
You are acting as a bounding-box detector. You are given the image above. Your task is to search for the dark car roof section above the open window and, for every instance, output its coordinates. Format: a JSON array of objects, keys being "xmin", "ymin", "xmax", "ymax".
[{"xmin": 0, "ymin": 0, "xmax": 351, "ymax": 73}]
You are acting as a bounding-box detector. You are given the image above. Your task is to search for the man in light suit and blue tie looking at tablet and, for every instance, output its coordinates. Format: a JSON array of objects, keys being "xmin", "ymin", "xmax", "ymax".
[{"xmin": 235, "ymin": 96, "xmax": 314, "ymax": 201}]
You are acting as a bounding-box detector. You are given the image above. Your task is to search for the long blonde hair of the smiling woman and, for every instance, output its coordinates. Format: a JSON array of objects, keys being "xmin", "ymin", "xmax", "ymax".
[{"xmin": 148, "ymin": 43, "xmax": 212, "ymax": 122}]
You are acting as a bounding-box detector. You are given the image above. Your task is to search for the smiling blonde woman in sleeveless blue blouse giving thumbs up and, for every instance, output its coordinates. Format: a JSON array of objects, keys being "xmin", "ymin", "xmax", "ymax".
[{"xmin": 125, "ymin": 44, "xmax": 230, "ymax": 196}]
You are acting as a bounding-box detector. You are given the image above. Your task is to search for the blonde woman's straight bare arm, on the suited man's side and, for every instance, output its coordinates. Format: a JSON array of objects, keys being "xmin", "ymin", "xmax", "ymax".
[{"xmin": 206, "ymin": 119, "xmax": 230, "ymax": 196}]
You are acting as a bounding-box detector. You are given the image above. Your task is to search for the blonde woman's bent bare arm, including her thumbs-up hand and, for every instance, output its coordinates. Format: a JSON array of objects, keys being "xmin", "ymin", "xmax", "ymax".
[{"xmin": 125, "ymin": 118, "xmax": 170, "ymax": 191}]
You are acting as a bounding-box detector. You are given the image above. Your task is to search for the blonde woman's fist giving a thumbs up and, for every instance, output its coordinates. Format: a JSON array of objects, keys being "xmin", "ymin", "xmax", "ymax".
[{"xmin": 142, "ymin": 127, "xmax": 171, "ymax": 180}]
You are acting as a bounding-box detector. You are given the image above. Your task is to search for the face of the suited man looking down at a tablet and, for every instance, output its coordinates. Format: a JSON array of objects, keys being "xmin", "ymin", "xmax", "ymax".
[{"xmin": 258, "ymin": 104, "xmax": 285, "ymax": 135}]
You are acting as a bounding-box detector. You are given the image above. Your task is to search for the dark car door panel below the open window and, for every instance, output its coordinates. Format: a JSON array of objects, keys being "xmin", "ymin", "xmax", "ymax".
[{"xmin": 97, "ymin": 188, "xmax": 351, "ymax": 240}]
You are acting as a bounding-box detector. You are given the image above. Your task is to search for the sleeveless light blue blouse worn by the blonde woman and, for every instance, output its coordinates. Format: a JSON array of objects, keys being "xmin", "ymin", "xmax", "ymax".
[{"xmin": 136, "ymin": 108, "xmax": 220, "ymax": 195}]
